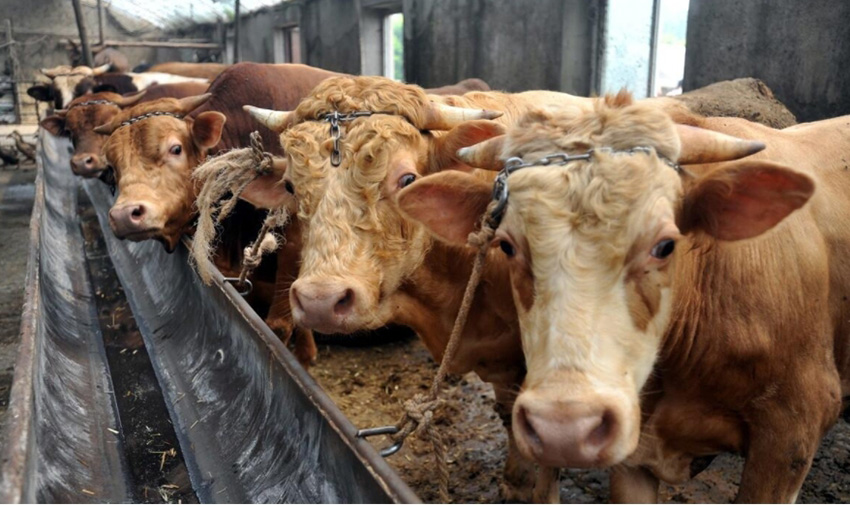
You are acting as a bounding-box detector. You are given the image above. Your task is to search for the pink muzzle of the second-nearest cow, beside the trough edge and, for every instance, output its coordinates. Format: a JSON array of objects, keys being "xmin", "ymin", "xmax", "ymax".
[{"xmin": 289, "ymin": 278, "xmax": 365, "ymax": 333}]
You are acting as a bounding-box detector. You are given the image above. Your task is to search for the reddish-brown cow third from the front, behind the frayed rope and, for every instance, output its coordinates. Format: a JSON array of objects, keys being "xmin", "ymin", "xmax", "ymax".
[{"xmin": 89, "ymin": 63, "xmax": 344, "ymax": 365}]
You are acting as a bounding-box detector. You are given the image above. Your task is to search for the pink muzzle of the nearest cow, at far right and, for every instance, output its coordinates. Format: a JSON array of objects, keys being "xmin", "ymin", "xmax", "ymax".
[{"xmin": 513, "ymin": 389, "xmax": 640, "ymax": 468}]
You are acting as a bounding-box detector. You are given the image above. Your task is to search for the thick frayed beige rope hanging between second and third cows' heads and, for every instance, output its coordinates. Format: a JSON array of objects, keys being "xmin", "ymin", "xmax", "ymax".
[{"xmin": 191, "ymin": 131, "xmax": 289, "ymax": 285}]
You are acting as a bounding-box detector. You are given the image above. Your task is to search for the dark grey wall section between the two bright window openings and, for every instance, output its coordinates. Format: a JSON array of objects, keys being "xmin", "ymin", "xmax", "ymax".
[{"xmin": 404, "ymin": 0, "xmax": 604, "ymax": 94}]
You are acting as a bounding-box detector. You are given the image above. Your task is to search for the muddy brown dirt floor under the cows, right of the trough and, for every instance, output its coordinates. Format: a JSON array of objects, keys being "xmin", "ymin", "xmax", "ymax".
[{"xmin": 311, "ymin": 332, "xmax": 850, "ymax": 503}]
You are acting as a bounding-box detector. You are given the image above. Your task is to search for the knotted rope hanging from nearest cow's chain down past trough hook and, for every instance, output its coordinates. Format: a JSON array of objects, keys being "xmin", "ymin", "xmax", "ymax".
[{"xmin": 390, "ymin": 208, "xmax": 496, "ymax": 503}]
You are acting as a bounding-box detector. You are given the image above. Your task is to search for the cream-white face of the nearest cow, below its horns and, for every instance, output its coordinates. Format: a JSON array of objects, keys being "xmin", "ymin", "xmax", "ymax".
[{"xmin": 494, "ymin": 153, "xmax": 681, "ymax": 467}]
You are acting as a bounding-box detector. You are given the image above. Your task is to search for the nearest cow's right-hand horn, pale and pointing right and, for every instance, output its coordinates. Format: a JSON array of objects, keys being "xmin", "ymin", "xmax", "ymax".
[{"xmin": 676, "ymin": 125, "xmax": 766, "ymax": 165}]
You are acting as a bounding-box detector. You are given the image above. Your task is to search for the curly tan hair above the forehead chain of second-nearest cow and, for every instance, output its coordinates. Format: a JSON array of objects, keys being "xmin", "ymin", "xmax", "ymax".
[{"xmin": 295, "ymin": 76, "xmax": 430, "ymax": 127}]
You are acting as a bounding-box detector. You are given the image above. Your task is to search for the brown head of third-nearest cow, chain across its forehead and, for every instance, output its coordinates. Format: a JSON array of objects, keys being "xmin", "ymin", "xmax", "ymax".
[{"xmin": 95, "ymin": 94, "xmax": 225, "ymax": 252}]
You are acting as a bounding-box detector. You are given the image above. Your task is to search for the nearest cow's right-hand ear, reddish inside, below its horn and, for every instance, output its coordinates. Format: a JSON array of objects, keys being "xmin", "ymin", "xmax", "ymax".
[{"xmin": 677, "ymin": 161, "xmax": 815, "ymax": 241}]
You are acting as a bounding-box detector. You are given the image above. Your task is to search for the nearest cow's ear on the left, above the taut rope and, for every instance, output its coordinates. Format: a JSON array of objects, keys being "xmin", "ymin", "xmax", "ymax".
[{"xmin": 398, "ymin": 170, "xmax": 493, "ymax": 245}]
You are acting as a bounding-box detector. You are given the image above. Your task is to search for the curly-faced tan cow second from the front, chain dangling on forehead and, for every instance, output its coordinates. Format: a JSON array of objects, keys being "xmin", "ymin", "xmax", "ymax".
[{"xmin": 235, "ymin": 76, "xmax": 595, "ymax": 501}]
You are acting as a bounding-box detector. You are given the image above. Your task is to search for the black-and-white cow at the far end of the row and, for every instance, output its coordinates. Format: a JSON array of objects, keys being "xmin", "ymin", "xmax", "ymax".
[{"xmin": 27, "ymin": 64, "xmax": 209, "ymax": 109}]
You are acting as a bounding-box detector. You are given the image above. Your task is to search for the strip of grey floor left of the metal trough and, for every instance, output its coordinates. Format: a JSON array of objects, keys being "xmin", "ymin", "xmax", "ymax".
[{"xmin": 0, "ymin": 165, "xmax": 36, "ymax": 447}]
